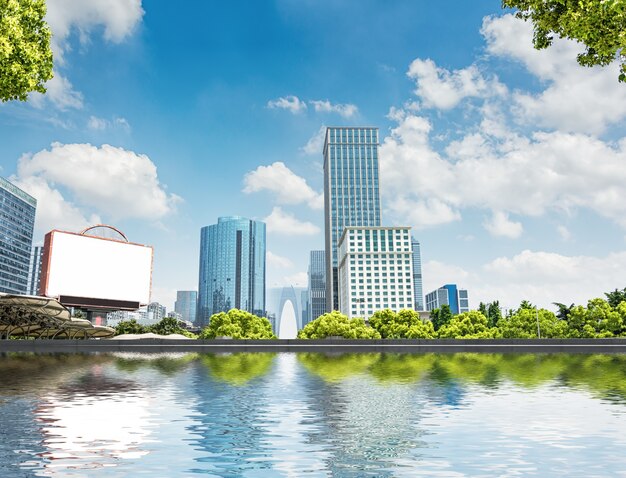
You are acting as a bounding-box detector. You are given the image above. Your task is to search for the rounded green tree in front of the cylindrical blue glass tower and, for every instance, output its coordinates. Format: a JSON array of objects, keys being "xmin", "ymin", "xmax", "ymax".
[{"xmin": 200, "ymin": 309, "xmax": 276, "ymax": 339}]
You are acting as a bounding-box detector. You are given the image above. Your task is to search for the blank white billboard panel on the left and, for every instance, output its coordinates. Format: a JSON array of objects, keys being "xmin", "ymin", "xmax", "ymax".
[{"xmin": 42, "ymin": 231, "xmax": 152, "ymax": 304}]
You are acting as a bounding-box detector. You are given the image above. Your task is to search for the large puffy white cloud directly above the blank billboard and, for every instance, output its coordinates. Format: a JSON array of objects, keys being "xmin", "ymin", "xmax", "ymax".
[{"xmin": 12, "ymin": 143, "xmax": 180, "ymax": 236}]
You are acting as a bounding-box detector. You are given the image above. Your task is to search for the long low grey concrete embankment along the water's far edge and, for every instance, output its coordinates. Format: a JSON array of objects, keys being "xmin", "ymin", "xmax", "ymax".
[{"xmin": 0, "ymin": 338, "xmax": 626, "ymax": 354}]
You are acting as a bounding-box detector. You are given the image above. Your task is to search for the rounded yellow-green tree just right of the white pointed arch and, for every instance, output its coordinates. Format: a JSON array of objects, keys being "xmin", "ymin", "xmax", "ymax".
[{"xmin": 298, "ymin": 310, "xmax": 381, "ymax": 339}]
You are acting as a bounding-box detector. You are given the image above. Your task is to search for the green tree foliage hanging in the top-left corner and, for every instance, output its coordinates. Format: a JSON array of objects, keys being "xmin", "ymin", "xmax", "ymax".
[{"xmin": 0, "ymin": 0, "xmax": 52, "ymax": 102}]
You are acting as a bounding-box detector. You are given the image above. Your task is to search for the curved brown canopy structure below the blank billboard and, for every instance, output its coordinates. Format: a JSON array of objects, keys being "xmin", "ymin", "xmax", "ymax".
[{"xmin": 0, "ymin": 294, "xmax": 115, "ymax": 339}]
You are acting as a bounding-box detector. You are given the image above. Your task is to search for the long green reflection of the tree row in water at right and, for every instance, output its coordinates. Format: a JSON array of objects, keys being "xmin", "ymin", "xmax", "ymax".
[{"xmin": 298, "ymin": 353, "xmax": 626, "ymax": 401}]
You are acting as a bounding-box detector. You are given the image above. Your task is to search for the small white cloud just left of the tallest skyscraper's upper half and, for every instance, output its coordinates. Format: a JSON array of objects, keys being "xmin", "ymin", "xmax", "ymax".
[{"xmin": 243, "ymin": 161, "xmax": 324, "ymax": 209}]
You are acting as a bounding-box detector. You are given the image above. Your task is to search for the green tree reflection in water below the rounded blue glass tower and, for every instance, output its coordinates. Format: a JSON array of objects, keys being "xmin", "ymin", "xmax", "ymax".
[{"xmin": 200, "ymin": 352, "xmax": 276, "ymax": 386}]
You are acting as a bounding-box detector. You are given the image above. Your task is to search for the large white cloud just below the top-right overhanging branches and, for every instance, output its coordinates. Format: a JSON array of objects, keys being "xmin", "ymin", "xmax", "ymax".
[{"xmin": 481, "ymin": 14, "xmax": 626, "ymax": 134}]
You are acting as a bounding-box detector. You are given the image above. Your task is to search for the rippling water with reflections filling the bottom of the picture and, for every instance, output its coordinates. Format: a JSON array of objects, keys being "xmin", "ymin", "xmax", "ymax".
[{"xmin": 0, "ymin": 353, "xmax": 626, "ymax": 478}]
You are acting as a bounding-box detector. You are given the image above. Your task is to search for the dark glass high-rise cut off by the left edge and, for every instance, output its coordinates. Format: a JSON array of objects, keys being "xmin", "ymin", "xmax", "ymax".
[{"xmin": 0, "ymin": 178, "xmax": 37, "ymax": 294}]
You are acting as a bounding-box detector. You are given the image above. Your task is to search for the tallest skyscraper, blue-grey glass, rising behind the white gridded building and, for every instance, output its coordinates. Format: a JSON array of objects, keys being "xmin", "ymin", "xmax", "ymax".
[{"xmin": 324, "ymin": 127, "xmax": 381, "ymax": 311}]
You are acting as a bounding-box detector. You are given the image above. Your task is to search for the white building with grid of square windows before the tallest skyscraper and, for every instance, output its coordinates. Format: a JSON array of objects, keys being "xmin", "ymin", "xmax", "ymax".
[{"xmin": 339, "ymin": 227, "xmax": 414, "ymax": 318}]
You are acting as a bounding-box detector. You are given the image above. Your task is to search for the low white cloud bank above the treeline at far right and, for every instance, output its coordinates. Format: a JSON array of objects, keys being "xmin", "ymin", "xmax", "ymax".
[{"xmin": 424, "ymin": 250, "xmax": 626, "ymax": 310}]
